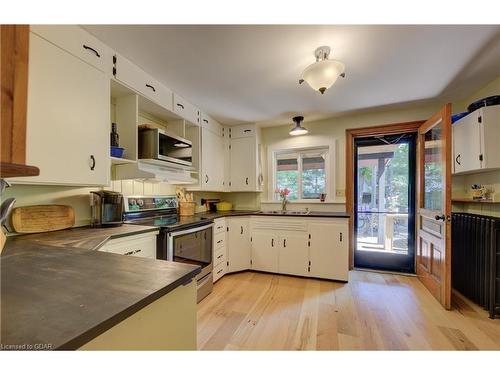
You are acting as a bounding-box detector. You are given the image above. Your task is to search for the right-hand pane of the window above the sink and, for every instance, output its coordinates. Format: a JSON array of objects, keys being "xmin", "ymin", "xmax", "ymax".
[{"xmin": 302, "ymin": 155, "xmax": 326, "ymax": 199}]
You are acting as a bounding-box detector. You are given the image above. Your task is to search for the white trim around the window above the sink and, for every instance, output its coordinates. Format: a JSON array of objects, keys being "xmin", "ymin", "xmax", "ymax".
[{"xmin": 267, "ymin": 136, "xmax": 336, "ymax": 203}]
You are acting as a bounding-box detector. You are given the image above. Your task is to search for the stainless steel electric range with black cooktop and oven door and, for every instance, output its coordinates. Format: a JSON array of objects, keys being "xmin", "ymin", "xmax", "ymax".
[{"xmin": 123, "ymin": 195, "xmax": 214, "ymax": 302}]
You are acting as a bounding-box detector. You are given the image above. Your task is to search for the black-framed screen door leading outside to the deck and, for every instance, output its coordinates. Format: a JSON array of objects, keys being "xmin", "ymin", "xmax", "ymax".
[{"xmin": 354, "ymin": 135, "xmax": 415, "ymax": 272}]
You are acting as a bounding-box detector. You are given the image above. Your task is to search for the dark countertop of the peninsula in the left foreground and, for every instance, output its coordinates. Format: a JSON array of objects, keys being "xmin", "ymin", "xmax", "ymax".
[{"xmin": 0, "ymin": 231, "xmax": 200, "ymax": 349}]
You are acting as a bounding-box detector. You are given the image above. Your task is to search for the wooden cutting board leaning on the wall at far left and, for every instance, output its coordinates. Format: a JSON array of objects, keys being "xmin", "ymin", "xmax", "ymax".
[{"xmin": 11, "ymin": 204, "xmax": 75, "ymax": 233}]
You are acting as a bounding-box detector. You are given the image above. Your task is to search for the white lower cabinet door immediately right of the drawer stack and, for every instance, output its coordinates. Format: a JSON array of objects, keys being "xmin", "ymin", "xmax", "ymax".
[{"xmin": 227, "ymin": 218, "xmax": 251, "ymax": 272}]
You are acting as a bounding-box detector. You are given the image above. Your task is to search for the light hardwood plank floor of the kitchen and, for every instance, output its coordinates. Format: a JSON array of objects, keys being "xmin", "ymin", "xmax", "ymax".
[{"xmin": 198, "ymin": 271, "xmax": 500, "ymax": 350}]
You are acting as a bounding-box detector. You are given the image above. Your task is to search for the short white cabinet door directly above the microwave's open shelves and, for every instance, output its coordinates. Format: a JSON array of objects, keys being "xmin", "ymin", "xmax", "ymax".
[{"xmin": 113, "ymin": 54, "xmax": 173, "ymax": 111}]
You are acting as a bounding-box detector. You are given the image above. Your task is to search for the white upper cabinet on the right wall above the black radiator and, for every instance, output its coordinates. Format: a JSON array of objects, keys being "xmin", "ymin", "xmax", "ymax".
[{"xmin": 452, "ymin": 105, "xmax": 500, "ymax": 173}]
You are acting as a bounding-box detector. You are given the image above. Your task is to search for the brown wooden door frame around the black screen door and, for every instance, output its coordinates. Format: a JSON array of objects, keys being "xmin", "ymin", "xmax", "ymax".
[{"xmin": 345, "ymin": 120, "xmax": 426, "ymax": 269}]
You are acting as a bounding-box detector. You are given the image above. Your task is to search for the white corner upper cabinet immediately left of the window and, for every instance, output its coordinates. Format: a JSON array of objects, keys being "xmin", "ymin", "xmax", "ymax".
[{"xmin": 229, "ymin": 125, "xmax": 263, "ymax": 191}]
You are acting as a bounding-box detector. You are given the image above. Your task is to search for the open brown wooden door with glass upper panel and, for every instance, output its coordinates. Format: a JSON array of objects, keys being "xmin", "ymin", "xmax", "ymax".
[{"xmin": 416, "ymin": 104, "xmax": 451, "ymax": 309}]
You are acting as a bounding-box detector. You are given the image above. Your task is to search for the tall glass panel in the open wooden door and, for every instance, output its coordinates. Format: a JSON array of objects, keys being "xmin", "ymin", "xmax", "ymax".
[{"xmin": 423, "ymin": 121, "xmax": 443, "ymax": 211}]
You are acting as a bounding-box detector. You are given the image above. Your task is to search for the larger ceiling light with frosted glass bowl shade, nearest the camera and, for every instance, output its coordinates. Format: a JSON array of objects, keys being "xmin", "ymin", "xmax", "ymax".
[{"xmin": 299, "ymin": 46, "xmax": 345, "ymax": 94}]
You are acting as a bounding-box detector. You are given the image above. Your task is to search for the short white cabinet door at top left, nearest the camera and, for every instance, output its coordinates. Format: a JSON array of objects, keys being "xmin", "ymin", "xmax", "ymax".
[{"xmin": 30, "ymin": 25, "xmax": 113, "ymax": 75}]
